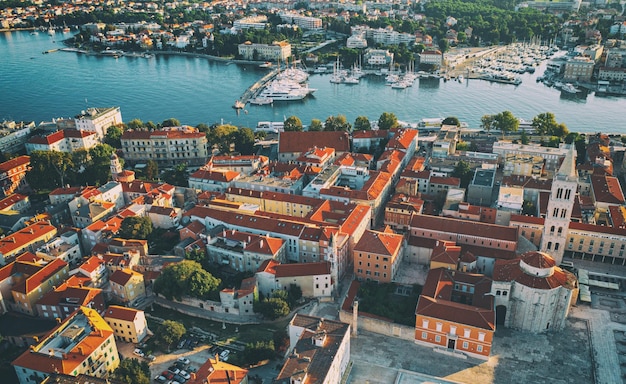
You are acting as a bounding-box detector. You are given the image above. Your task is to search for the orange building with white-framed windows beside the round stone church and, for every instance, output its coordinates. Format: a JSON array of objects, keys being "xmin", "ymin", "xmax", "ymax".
[{"xmin": 415, "ymin": 268, "xmax": 496, "ymax": 360}]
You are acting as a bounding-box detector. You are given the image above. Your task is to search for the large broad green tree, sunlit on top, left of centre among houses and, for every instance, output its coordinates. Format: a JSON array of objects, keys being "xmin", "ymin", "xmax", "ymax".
[{"xmin": 154, "ymin": 260, "xmax": 221, "ymax": 300}]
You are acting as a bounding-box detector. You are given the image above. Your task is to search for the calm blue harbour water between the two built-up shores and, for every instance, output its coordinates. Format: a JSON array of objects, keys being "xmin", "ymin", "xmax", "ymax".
[{"xmin": 0, "ymin": 32, "xmax": 626, "ymax": 133}]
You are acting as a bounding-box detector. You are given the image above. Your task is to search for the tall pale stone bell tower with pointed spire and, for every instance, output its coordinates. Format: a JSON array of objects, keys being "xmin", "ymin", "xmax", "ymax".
[{"xmin": 540, "ymin": 144, "xmax": 578, "ymax": 265}]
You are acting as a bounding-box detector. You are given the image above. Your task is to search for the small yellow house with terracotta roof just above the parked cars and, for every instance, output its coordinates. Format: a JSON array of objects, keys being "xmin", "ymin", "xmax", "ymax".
[{"xmin": 104, "ymin": 305, "xmax": 150, "ymax": 343}]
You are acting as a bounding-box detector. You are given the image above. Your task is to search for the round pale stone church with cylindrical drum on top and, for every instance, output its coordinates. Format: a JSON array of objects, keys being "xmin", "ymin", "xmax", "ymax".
[{"xmin": 489, "ymin": 252, "xmax": 578, "ymax": 333}]
